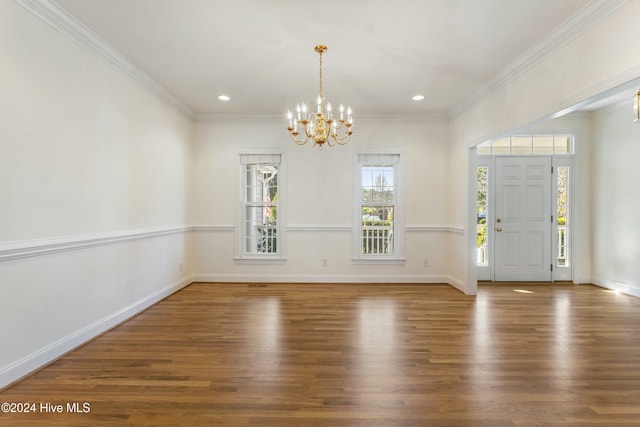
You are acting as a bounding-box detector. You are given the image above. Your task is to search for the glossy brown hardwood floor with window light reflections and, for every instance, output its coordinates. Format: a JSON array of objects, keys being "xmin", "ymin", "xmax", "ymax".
[{"xmin": 0, "ymin": 283, "xmax": 640, "ymax": 427}]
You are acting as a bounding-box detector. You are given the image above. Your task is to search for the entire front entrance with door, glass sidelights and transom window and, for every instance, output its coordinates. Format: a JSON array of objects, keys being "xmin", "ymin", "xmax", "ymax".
[{"xmin": 476, "ymin": 134, "xmax": 574, "ymax": 282}]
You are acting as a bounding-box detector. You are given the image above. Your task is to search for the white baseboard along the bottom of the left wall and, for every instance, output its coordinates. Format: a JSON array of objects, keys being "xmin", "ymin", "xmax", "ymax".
[{"xmin": 0, "ymin": 276, "xmax": 194, "ymax": 390}]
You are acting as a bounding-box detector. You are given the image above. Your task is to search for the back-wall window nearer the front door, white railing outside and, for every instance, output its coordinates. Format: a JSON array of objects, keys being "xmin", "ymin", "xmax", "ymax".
[{"xmin": 354, "ymin": 153, "xmax": 401, "ymax": 259}]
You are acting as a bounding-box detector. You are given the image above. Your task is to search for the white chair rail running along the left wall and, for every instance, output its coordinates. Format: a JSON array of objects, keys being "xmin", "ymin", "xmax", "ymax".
[{"xmin": 0, "ymin": 226, "xmax": 190, "ymax": 262}]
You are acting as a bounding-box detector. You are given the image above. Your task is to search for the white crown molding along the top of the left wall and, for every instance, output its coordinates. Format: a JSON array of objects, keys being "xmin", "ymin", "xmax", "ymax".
[{"xmin": 14, "ymin": 0, "xmax": 195, "ymax": 120}]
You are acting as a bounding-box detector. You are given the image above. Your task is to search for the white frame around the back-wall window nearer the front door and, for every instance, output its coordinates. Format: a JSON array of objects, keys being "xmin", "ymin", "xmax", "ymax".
[{"xmin": 352, "ymin": 149, "xmax": 406, "ymax": 264}]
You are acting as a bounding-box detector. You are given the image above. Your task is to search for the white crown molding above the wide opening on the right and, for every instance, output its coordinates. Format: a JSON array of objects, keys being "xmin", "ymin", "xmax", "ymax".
[{"xmin": 449, "ymin": 0, "xmax": 630, "ymax": 119}]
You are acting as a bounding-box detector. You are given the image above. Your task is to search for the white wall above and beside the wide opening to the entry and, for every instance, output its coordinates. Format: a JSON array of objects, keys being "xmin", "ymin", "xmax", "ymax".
[{"xmin": 449, "ymin": 0, "xmax": 640, "ymax": 292}]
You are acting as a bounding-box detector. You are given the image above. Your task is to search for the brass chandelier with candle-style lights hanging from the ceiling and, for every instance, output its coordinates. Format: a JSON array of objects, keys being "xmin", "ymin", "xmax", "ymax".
[{"xmin": 287, "ymin": 44, "xmax": 353, "ymax": 148}]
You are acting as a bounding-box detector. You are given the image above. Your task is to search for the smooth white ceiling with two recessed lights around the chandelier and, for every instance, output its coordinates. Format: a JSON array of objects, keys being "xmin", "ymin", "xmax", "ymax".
[{"xmin": 56, "ymin": 0, "xmax": 589, "ymax": 120}]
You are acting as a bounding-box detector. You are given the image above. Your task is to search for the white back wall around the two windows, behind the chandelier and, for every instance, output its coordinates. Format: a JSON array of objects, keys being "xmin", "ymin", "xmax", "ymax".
[{"xmin": 194, "ymin": 117, "xmax": 458, "ymax": 285}]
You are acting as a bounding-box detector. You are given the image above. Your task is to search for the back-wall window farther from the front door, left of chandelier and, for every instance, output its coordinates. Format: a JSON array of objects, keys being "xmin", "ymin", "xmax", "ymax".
[{"xmin": 240, "ymin": 154, "xmax": 281, "ymax": 257}]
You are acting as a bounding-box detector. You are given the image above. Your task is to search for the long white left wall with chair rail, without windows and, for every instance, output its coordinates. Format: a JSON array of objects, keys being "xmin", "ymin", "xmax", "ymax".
[{"xmin": 0, "ymin": 1, "xmax": 193, "ymax": 387}]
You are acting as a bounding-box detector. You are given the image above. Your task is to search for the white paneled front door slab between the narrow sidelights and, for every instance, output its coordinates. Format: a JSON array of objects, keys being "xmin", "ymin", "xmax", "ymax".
[{"xmin": 493, "ymin": 157, "xmax": 552, "ymax": 281}]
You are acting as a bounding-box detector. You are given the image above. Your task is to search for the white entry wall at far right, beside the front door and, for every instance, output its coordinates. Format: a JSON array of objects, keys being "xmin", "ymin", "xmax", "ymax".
[{"xmin": 592, "ymin": 102, "xmax": 640, "ymax": 296}]
